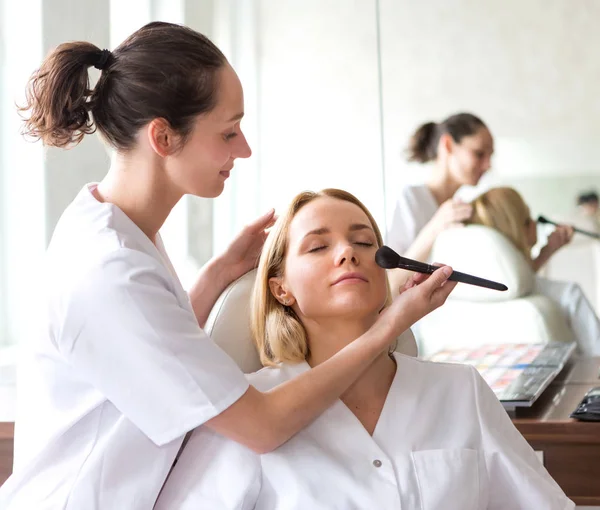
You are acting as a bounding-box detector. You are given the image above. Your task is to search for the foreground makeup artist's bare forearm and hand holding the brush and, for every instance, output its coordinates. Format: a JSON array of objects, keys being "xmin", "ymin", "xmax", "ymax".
[{"xmin": 206, "ymin": 268, "xmax": 456, "ymax": 453}]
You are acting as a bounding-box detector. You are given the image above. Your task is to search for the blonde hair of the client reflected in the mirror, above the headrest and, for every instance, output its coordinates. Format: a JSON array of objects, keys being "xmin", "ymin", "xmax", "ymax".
[{"xmin": 466, "ymin": 188, "xmax": 531, "ymax": 260}]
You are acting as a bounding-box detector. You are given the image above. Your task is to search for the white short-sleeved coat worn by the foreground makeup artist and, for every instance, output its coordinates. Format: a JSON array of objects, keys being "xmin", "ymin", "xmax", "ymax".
[{"xmin": 0, "ymin": 185, "xmax": 248, "ymax": 510}]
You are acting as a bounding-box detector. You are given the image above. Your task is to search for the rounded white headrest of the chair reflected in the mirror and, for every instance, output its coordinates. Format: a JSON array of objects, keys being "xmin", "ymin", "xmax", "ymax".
[{"xmin": 430, "ymin": 225, "xmax": 534, "ymax": 301}]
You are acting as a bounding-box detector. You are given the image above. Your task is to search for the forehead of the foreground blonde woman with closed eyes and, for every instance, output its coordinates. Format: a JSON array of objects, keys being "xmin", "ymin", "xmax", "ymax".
[{"xmin": 289, "ymin": 197, "xmax": 372, "ymax": 243}]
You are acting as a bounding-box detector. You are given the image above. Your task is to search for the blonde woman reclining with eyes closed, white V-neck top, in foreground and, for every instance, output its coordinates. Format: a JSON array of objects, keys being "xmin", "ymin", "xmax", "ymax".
[{"xmin": 156, "ymin": 190, "xmax": 574, "ymax": 510}]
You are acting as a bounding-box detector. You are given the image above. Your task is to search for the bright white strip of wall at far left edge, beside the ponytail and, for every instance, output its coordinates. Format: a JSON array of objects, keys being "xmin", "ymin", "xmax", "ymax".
[{"xmin": 0, "ymin": 0, "xmax": 45, "ymax": 347}]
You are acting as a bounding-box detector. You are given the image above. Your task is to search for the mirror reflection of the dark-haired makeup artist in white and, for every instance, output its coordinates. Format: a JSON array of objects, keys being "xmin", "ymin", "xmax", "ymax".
[{"xmin": 386, "ymin": 113, "xmax": 494, "ymax": 288}]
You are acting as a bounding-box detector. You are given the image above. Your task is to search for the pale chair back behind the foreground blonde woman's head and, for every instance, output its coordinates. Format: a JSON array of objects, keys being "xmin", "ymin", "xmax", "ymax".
[{"xmin": 204, "ymin": 270, "xmax": 417, "ymax": 373}]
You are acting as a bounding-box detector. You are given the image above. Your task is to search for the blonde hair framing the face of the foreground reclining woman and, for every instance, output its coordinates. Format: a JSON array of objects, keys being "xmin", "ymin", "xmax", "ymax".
[{"xmin": 250, "ymin": 188, "xmax": 391, "ymax": 366}]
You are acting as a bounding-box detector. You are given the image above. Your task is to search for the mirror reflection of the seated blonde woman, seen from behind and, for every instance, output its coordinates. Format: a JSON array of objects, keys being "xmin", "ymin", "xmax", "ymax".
[{"xmin": 467, "ymin": 188, "xmax": 600, "ymax": 356}]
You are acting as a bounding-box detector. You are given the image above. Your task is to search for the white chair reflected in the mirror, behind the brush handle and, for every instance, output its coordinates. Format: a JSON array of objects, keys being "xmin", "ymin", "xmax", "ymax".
[{"xmin": 415, "ymin": 225, "xmax": 574, "ymax": 356}]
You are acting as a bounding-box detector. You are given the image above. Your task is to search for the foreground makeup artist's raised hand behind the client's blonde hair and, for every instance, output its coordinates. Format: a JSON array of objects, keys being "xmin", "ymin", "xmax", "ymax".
[{"xmin": 220, "ymin": 209, "xmax": 277, "ymax": 284}]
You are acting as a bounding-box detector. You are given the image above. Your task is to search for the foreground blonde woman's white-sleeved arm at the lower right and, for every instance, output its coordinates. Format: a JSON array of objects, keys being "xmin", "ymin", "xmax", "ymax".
[{"xmin": 471, "ymin": 368, "xmax": 575, "ymax": 510}]
